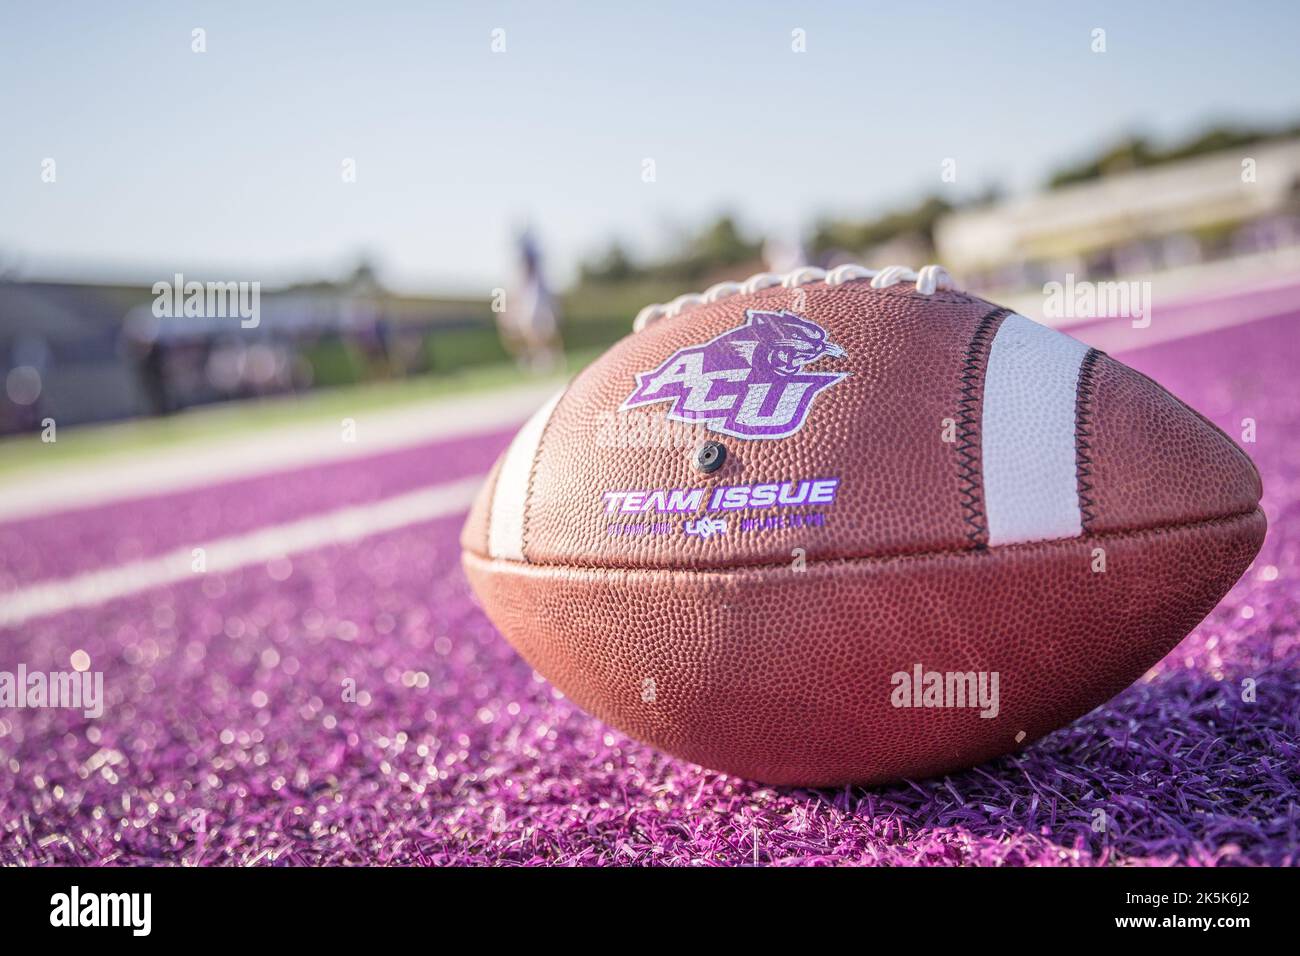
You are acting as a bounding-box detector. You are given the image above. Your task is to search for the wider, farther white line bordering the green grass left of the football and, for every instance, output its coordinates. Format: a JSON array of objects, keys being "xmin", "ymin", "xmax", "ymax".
[{"xmin": 0, "ymin": 381, "xmax": 556, "ymax": 522}]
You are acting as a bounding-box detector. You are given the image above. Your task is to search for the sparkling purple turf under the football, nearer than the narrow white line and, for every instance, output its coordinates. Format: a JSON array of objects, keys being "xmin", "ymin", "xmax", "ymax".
[{"xmin": 0, "ymin": 304, "xmax": 1300, "ymax": 865}]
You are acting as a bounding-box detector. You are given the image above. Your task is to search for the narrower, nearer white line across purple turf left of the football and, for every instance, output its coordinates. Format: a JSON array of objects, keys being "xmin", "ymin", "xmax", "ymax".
[{"xmin": 0, "ymin": 475, "xmax": 484, "ymax": 627}]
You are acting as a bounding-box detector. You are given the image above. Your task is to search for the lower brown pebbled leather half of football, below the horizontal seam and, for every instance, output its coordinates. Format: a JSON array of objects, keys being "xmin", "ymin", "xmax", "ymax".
[{"xmin": 464, "ymin": 511, "xmax": 1265, "ymax": 786}]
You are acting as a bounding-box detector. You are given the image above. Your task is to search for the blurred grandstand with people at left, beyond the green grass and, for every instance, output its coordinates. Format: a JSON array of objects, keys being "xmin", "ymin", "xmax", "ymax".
[{"xmin": 0, "ymin": 267, "xmax": 504, "ymax": 433}]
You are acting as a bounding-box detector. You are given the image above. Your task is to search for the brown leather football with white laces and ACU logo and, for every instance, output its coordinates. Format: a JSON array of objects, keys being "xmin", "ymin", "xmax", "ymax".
[{"xmin": 462, "ymin": 265, "xmax": 1265, "ymax": 786}]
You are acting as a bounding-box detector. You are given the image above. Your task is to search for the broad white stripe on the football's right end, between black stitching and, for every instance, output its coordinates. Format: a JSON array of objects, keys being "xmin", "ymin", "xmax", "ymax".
[{"xmin": 982, "ymin": 315, "xmax": 1088, "ymax": 545}]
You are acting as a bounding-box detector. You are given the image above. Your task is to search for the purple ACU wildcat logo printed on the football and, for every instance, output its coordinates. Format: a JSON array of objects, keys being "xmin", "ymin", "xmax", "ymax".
[{"xmin": 621, "ymin": 308, "xmax": 849, "ymax": 438}]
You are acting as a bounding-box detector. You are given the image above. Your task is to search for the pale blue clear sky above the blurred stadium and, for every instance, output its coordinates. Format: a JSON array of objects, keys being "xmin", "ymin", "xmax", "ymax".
[{"xmin": 0, "ymin": 0, "xmax": 1300, "ymax": 294}]
